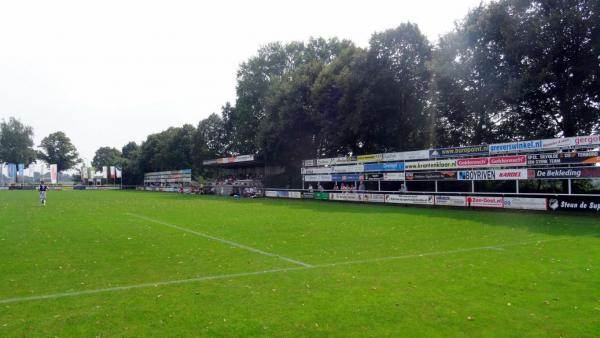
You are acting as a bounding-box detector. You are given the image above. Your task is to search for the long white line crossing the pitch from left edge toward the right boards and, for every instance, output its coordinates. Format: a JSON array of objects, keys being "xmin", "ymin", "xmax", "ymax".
[{"xmin": 0, "ymin": 238, "xmax": 566, "ymax": 304}]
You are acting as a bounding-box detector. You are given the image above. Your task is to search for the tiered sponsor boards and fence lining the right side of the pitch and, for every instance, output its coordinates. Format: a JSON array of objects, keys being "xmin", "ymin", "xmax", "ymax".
[{"xmin": 265, "ymin": 135, "xmax": 600, "ymax": 211}]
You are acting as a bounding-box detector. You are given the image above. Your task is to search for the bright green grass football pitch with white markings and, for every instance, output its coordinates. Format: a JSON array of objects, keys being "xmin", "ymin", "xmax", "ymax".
[{"xmin": 0, "ymin": 191, "xmax": 600, "ymax": 337}]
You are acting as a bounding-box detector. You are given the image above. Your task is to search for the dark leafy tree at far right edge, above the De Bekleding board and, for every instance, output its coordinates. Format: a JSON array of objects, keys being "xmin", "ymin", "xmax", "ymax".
[{"xmin": 506, "ymin": 0, "xmax": 600, "ymax": 136}]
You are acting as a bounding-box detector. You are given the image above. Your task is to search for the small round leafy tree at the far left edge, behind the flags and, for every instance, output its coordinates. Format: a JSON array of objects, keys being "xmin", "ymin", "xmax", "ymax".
[{"xmin": 0, "ymin": 117, "xmax": 36, "ymax": 164}]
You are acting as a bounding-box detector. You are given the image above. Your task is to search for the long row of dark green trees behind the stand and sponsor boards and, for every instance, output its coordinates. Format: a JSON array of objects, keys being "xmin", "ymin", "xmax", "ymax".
[{"xmin": 2, "ymin": 0, "xmax": 600, "ymax": 187}]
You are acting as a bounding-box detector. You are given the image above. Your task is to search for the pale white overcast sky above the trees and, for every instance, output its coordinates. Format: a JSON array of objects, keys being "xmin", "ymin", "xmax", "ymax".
[{"xmin": 0, "ymin": 0, "xmax": 480, "ymax": 162}]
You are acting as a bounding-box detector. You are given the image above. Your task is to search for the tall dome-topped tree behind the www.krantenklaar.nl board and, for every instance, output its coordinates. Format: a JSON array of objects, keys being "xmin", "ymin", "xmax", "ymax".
[{"xmin": 358, "ymin": 23, "xmax": 432, "ymax": 152}]
